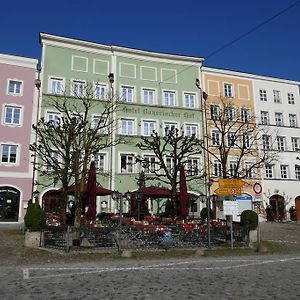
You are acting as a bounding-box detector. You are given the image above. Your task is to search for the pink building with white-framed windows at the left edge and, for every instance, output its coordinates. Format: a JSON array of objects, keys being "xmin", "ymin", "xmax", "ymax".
[{"xmin": 0, "ymin": 54, "xmax": 38, "ymax": 222}]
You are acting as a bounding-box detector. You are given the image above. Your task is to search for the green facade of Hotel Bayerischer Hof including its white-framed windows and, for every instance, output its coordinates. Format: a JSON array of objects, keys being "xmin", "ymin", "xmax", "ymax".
[{"xmin": 37, "ymin": 33, "xmax": 204, "ymax": 216}]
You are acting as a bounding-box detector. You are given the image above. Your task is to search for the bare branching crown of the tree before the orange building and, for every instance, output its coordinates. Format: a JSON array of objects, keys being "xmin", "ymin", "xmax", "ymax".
[{"xmin": 201, "ymin": 97, "xmax": 277, "ymax": 178}]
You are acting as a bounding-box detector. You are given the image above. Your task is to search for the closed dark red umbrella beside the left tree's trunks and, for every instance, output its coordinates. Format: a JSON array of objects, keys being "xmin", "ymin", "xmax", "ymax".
[{"xmin": 86, "ymin": 161, "xmax": 96, "ymax": 223}]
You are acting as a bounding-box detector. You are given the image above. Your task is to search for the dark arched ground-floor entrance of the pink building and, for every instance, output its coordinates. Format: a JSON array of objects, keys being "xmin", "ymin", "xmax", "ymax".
[{"xmin": 0, "ymin": 186, "xmax": 20, "ymax": 222}]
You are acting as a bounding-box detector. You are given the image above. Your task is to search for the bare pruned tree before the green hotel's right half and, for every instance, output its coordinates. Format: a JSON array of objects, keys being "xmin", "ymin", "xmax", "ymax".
[{"xmin": 136, "ymin": 127, "xmax": 203, "ymax": 216}]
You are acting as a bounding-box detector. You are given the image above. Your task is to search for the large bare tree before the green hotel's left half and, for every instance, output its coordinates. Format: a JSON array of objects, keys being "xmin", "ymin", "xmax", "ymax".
[{"xmin": 30, "ymin": 84, "xmax": 120, "ymax": 225}]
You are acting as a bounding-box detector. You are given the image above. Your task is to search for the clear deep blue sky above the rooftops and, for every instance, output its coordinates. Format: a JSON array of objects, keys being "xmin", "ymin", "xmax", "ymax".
[{"xmin": 0, "ymin": 0, "xmax": 300, "ymax": 81}]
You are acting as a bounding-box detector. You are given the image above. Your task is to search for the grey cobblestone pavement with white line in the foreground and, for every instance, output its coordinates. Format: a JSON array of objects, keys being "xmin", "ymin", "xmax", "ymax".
[{"xmin": 0, "ymin": 223, "xmax": 300, "ymax": 300}]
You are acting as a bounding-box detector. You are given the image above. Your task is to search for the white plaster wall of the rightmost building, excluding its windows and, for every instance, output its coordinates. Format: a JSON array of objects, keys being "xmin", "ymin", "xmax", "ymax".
[{"xmin": 253, "ymin": 76, "xmax": 300, "ymax": 216}]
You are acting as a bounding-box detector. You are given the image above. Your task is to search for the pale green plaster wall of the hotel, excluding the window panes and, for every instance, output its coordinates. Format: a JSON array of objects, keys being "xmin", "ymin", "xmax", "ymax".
[{"xmin": 40, "ymin": 34, "xmax": 203, "ymax": 217}]
